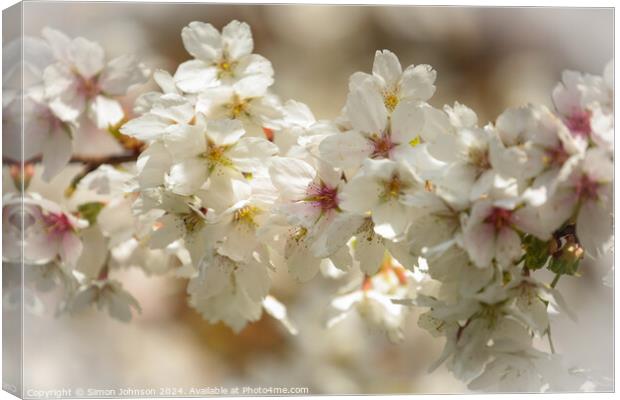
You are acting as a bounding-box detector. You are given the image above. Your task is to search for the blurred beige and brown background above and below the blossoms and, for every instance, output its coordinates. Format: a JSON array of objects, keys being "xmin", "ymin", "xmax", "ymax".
[{"xmin": 12, "ymin": 2, "xmax": 613, "ymax": 394}]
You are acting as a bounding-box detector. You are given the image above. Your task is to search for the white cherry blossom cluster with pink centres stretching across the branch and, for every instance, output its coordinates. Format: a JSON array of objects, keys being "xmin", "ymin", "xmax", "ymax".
[{"xmin": 3, "ymin": 21, "xmax": 614, "ymax": 390}]
